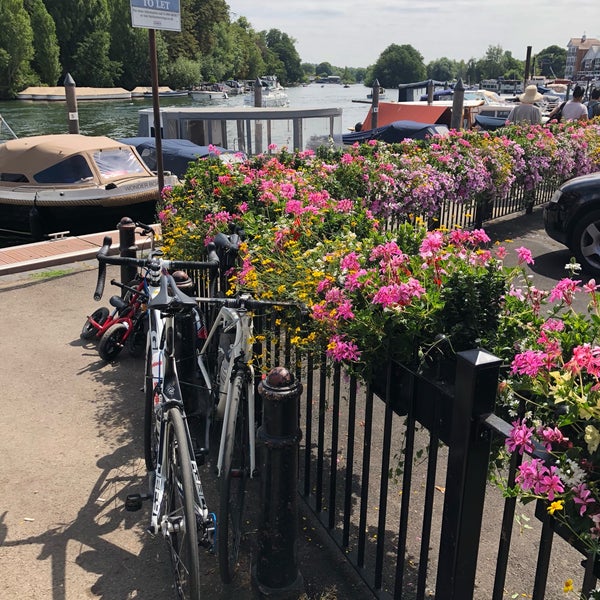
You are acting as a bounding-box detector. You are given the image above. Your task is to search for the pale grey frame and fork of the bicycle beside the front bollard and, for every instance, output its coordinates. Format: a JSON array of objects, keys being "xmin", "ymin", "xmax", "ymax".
[{"xmin": 198, "ymin": 306, "xmax": 256, "ymax": 477}]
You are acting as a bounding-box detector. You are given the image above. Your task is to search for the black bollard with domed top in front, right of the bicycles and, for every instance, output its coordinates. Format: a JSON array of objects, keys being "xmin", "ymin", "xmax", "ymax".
[{"xmin": 252, "ymin": 367, "xmax": 304, "ymax": 598}]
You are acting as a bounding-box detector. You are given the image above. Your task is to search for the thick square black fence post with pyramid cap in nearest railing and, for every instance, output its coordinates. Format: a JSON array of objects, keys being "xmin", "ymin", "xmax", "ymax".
[{"xmin": 436, "ymin": 349, "xmax": 501, "ymax": 600}]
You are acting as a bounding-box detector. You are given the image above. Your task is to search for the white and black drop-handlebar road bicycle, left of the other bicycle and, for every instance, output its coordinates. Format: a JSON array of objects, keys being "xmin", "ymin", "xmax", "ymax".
[{"xmin": 95, "ymin": 233, "xmax": 218, "ymax": 600}]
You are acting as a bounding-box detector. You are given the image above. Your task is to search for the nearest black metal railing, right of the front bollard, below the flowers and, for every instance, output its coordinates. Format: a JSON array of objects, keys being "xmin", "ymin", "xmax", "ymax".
[{"xmin": 298, "ymin": 350, "xmax": 596, "ymax": 600}]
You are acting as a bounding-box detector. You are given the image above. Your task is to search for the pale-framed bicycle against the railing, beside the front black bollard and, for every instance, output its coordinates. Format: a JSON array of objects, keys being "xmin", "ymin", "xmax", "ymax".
[{"xmin": 192, "ymin": 234, "xmax": 303, "ymax": 583}]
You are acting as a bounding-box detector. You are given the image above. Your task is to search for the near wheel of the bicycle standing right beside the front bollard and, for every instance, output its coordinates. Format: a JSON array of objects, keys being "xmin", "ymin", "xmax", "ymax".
[{"xmin": 218, "ymin": 373, "xmax": 250, "ymax": 583}]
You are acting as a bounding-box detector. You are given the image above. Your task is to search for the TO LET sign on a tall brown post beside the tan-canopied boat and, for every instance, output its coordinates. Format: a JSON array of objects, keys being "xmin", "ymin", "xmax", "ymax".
[{"xmin": 130, "ymin": 0, "xmax": 181, "ymax": 194}]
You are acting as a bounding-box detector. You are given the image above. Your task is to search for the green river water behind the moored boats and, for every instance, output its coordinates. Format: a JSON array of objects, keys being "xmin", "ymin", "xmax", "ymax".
[{"xmin": 0, "ymin": 83, "xmax": 370, "ymax": 138}]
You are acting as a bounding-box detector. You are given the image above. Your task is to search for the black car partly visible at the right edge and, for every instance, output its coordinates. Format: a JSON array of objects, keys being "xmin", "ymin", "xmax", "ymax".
[{"xmin": 544, "ymin": 172, "xmax": 600, "ymax": 275}]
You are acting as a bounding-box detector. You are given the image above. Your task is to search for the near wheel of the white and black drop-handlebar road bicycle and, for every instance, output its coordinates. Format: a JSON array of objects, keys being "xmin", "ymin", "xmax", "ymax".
[{"xmin": 161, "ymin": 408, "xmax": 200, "ymax": 600}]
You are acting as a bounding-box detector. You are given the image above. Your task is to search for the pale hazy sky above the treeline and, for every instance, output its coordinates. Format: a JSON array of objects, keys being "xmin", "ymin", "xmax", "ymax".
[{"xmin": 226, "ymin": 0, "xmax": 600, "ymax": 67}]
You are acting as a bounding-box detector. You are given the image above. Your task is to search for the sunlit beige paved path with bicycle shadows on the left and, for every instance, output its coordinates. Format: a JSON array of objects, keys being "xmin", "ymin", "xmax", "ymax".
[{"xmin": 0, "ymin": 261, "xmax": 369, "ymax": 600}]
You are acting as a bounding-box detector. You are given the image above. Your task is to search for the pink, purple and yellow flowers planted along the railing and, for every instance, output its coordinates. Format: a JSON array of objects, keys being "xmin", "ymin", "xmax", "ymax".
[{"xmin": 160, "ymin": 120, "xmax": 600, "ymax": 580}]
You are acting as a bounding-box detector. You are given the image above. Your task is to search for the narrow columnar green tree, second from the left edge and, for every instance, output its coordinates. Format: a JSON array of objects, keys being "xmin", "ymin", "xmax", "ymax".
[{"xmin": 24, "ymin": 0, "xmax": 61, "ymax": 85}]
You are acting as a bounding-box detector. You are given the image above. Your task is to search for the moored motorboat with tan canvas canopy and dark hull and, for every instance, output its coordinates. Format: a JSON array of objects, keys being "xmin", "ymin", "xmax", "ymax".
[{"xmin": 0, "ymin": 134, "xmax": 179, "ymax": 239}]
